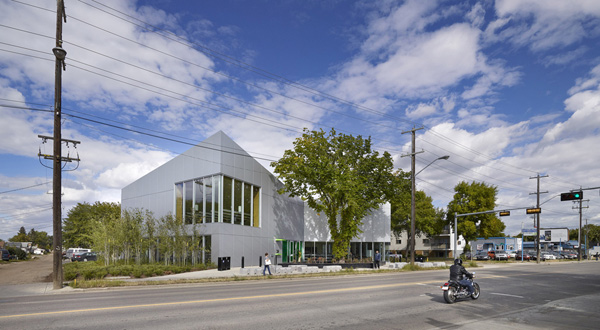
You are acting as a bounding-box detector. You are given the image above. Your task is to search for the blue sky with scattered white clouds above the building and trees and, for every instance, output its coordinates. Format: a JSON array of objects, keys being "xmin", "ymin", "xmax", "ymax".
[{"xmin": 0, "ymin": 0, "xmax": 600, "ymax": 240}]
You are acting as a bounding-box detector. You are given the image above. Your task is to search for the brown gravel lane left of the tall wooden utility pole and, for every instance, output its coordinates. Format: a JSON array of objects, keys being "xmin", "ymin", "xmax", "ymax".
[{"xmin": 0, "ymin": 254, "xmax": 52, "ymax": 285}]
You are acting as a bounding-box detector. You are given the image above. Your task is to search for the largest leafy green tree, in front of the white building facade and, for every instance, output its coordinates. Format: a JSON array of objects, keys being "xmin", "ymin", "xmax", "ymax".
[{"xmin": 271, "ymin": 129, "xmax": 394, "ymax": 258}]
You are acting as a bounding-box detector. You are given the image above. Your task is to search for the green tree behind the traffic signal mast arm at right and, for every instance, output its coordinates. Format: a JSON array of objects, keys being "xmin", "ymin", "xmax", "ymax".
[{"xmin": 448, "ymin": 181, "xmax": 506, "ymax": 242}]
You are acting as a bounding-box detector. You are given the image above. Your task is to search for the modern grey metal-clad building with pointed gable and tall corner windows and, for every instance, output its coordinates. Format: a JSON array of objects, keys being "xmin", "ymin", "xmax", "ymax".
[{"xmin": 121, "ymin": 132, "xmax": 390, "ymax": 267}]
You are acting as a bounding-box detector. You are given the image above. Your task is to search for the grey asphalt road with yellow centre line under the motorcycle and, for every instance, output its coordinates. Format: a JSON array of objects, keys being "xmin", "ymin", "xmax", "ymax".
[{"xmin": 0, "ymin": 261, "xmax": 600, "ymax": 330}]
